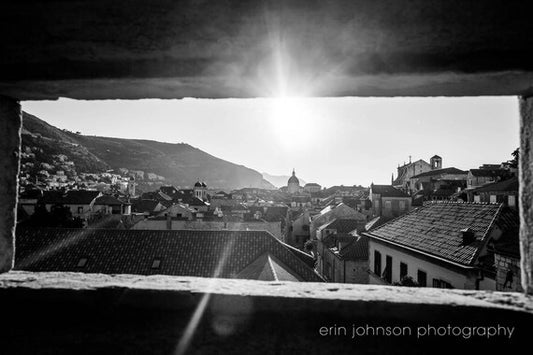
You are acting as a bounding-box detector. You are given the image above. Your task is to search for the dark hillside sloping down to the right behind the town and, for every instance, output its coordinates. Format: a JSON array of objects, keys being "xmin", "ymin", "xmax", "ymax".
[{"xmin": 22, "ymin": 112, "xmax": 274, "ymax": 189}]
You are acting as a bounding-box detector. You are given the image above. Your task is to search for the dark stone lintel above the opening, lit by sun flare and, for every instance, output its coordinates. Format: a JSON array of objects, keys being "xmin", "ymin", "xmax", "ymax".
[{"xmin": 0, "ymin": 0, "xmax": 533, "ymax": 99}]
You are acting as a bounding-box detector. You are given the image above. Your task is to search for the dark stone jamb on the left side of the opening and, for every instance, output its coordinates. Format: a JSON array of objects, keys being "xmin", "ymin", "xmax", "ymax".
[{"xmin": 0, "ymin": 96, "xmax": 22, "ymax": 273}]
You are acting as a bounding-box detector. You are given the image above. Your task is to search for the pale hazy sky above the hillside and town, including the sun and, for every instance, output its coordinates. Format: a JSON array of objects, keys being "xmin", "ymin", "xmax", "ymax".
[{"xmin": 23, "ymin": 97, "xmax": 519, "ymax": 186}]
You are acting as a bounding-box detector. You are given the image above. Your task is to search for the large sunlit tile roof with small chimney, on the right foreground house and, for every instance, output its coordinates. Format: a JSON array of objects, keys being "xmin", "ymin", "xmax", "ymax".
[{"xmin": 364, "ymin": 202, "xmax": 508, "ymax": 266}]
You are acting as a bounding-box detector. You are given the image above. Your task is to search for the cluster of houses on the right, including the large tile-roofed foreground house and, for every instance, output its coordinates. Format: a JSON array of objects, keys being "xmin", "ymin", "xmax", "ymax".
[{"xmin": 307, "ymin": 155, "xmax": 521, "ymax": 291}]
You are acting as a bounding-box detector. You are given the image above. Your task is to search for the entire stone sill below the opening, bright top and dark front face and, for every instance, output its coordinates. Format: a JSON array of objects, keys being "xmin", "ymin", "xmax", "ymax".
[{"xmin": 0, "ymin": 272, "xmax": 533, "ymax": 354}]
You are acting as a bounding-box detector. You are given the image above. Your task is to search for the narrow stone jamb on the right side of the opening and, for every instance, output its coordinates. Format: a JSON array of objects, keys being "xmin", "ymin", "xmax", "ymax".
[{"xmin": 519, "ymin": 97, "xmax": 533, "ymax": 295}]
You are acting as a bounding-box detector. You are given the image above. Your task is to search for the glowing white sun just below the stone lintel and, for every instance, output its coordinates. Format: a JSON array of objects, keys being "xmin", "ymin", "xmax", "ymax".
[{"xmin": 270, "ymin": 97, "xmax": 318, "ymax": 149}]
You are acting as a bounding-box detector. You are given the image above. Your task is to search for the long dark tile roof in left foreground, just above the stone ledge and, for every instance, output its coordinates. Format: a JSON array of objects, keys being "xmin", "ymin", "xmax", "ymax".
[{"xmin": 15, "ymin": 228, "xmax": 321, "ymax": 282}]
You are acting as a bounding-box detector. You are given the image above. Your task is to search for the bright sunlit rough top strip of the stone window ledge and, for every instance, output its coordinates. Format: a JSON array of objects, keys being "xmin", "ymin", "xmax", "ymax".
[{"xmin": 0, "ymin": 271, "xmax": 533, "ymax": 315}]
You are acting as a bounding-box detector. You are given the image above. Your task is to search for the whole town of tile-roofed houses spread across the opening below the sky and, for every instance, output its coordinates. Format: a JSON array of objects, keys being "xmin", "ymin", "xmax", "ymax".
[{"xmin": 17, "ymin": 155, "xmax": 521, "ymax": 291}]
